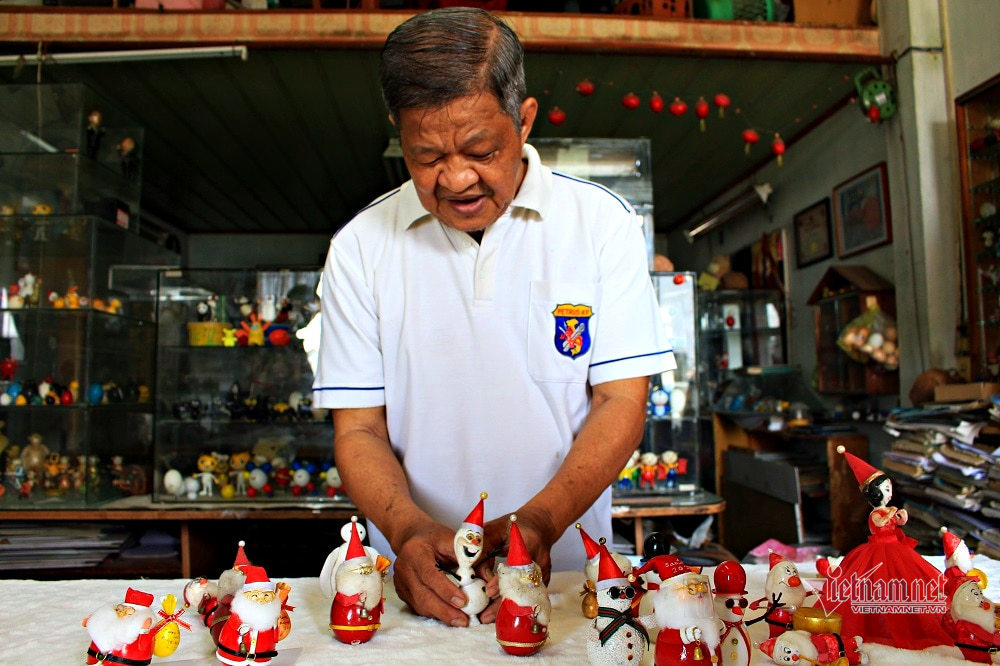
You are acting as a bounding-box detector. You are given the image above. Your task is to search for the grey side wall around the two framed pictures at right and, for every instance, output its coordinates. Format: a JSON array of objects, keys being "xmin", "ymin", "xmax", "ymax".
[{"xmin": 667, "ymin": 105, "xmax": 892, "ymax": 404}]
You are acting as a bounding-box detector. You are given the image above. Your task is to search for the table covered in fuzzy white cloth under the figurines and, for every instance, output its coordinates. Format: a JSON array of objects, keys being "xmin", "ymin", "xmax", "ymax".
[{"xmin": 0, "ymin": 556, "xmax": 1000, "ymax": 666}]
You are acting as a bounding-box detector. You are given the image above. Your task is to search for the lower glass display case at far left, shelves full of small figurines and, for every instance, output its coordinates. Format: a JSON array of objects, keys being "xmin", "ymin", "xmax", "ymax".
[{"xmin": 0, "ymin": 216, "xmax": 177, "ymax": 509}]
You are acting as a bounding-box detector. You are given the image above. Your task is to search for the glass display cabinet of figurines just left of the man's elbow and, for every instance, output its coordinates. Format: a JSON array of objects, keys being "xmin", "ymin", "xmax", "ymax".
[{"xmin": 153, "ymin": 268, "xmax": 346, "ymax": 504}]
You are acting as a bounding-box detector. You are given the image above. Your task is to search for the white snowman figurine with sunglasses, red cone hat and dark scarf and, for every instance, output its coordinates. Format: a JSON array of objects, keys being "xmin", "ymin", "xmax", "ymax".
[{"xmin": 587, "ymin": 545, "xmax": 656, "ymax": 666}]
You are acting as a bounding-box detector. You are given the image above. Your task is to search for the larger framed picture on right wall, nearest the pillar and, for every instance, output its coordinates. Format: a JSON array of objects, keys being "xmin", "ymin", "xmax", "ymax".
[{"xmin": 833, "ymin": 162, "xmax": 892, "ymax": 258}]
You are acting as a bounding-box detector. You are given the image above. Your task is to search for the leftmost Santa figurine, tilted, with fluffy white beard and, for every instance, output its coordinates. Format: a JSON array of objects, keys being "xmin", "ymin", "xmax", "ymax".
[{"xmin": 83, "ymin": 587, "xmax": 154, "ymax": 666}]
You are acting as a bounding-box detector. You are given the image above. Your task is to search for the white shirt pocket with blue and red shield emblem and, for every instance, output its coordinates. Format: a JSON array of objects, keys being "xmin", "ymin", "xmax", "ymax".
[{"xmin": 528, "ymin": 280, "xmax": 600, "ymax": 383}]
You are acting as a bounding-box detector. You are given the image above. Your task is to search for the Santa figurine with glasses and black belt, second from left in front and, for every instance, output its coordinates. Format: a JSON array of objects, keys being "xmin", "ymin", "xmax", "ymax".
[{"xmin": 212, "ymin": 564, "xmax": 282, "ymax": 666}]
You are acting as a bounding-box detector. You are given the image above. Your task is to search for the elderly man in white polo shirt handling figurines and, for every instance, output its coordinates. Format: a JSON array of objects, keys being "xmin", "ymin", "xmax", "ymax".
[{"xmin": 313, "ymin": 9, "xmax": 674, "ymax": 626}]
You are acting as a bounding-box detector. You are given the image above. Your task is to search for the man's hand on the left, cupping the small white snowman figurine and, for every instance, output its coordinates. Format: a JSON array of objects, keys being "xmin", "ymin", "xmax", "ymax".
[{"xmin": 393, "ymin": 522, "xmax": 469, "ymax": 627}]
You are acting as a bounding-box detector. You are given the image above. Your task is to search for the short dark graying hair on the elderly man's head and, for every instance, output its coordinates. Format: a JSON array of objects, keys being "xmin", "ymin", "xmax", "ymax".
[{"xmin": 379, "ymin": 7, "xmax": 527, "ymax": 126}]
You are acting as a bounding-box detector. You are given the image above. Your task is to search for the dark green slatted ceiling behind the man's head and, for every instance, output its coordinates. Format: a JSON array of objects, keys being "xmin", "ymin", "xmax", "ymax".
[{"xmin": 0, "ymin": 42, "xmax": 876, "ymax": 239}]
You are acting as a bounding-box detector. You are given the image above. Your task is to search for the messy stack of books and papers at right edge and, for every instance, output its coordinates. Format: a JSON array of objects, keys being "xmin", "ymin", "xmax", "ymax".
[{"xmin": 881, "ymin": 400, "xmax": 1000, "ymax": 557}]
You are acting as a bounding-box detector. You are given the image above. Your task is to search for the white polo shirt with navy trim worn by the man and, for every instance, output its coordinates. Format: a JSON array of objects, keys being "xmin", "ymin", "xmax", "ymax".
[{"xmin": 313, "ymin": 145, "xmax": 675, "ymax": 570}]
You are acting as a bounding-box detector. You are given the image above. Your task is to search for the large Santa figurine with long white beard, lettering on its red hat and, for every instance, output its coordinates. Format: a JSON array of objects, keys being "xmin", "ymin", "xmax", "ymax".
[{"xmin": 629, "ymin": 555, "xmax": 722, "ymax": 666}]
